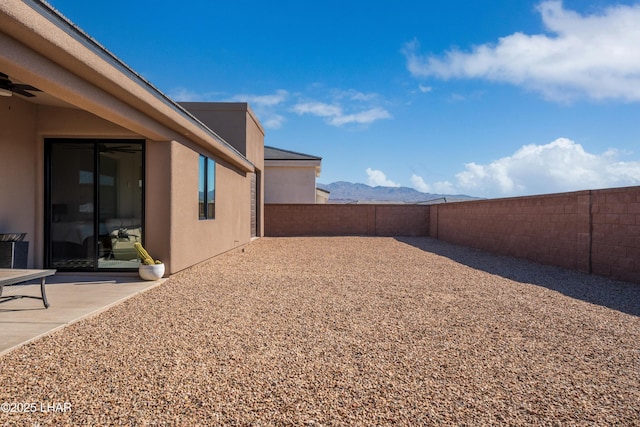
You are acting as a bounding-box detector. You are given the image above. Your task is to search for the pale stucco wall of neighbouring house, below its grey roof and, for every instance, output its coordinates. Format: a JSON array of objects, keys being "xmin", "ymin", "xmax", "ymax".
[{"xmin": 264, "ymin": 166, "xmax": 316, "ymax": 203}]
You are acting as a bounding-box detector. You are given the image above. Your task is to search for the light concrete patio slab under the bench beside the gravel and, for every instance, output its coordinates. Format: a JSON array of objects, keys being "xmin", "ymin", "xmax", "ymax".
[{"xmin": 0, "ymin": 273, "xmax": 166, "ymax": 355}]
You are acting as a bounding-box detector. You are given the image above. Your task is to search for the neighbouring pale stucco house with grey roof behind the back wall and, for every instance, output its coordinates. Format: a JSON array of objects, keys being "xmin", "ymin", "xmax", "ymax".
[{"xmin": 264, "ymin": 146, "xmax": 329, "ymax": 203}]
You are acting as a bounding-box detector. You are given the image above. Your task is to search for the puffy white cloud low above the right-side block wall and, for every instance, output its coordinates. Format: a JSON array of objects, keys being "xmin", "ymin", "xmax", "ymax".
[{"xmin": 412, "ymin": 138, "xmax": 640, "ymax": 197}]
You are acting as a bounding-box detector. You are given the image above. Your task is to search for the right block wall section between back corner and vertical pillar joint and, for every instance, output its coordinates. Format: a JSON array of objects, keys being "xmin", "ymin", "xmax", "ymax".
[{"xmin": 430, "ymin": 192, "xmax": 589, "ymax": 272}]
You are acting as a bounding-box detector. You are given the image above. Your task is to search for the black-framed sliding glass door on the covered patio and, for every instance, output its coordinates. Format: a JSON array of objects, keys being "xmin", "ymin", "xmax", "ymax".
[{"xmin": 45, "ymin": 139, "xmax": 144, "ymax": 271}]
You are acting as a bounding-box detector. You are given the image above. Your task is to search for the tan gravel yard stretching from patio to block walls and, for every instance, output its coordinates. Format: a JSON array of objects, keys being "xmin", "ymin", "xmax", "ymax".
[{"xmin": 0, "ymin": 237, "xmax": 640, "ymax": 426}]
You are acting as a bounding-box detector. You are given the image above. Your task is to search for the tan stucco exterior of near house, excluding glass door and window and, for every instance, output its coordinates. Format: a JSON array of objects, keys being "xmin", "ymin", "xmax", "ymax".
[{"xmin": 0, "ymin": 1, "xmax": 264, "ymax": 273}]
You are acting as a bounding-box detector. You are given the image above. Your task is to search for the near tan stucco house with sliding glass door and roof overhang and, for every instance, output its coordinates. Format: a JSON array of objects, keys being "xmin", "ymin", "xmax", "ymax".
[{"xmin": 0, "ymin": 0, "xmax": 264, "ymax": 274}]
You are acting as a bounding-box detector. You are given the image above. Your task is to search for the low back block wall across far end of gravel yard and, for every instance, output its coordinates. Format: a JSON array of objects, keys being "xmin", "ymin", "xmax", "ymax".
[{"xmin": 264, "ymin": 204, "xmax": 429, "ymax": 237}]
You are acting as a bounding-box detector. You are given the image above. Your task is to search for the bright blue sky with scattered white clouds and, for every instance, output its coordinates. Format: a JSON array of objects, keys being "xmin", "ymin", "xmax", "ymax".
[{"xmin": 51, "ymin": 0, "xmax": 640, "ymax": 197}]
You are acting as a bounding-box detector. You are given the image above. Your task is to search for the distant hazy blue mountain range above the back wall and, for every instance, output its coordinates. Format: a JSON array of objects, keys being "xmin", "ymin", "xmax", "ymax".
[{"xmin": 317, "ymin": 181, "xmax": 478, "ymax": 203}]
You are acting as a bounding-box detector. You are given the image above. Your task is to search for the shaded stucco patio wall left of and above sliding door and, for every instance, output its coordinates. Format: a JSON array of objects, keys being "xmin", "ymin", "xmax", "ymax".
[{"xmin": 0, "ymin": 96, "xmax": 137, "ymax": 267}]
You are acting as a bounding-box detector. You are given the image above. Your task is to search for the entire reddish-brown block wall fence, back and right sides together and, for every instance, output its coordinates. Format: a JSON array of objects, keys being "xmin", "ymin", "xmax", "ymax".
[{"xmin": 265, "ymin": 187, "xmax": 640, "ymax": 283}]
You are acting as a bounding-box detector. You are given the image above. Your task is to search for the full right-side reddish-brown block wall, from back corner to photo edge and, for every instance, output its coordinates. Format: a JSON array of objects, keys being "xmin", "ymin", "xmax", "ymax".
[{"xmin": 429, "ymin": 187, "xmax": 640, "ymax": 283}]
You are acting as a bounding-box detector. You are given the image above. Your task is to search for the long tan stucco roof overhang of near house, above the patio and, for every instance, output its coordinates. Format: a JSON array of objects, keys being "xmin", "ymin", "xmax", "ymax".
[{"xmin": 0, "ymin": 0, "xmax": 255, "ymax": 172}]
